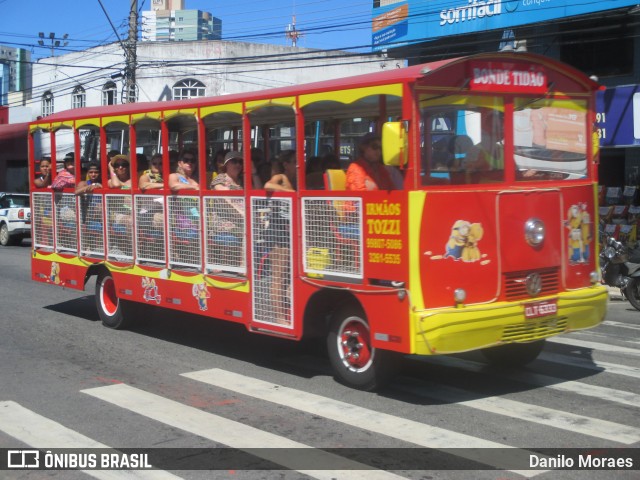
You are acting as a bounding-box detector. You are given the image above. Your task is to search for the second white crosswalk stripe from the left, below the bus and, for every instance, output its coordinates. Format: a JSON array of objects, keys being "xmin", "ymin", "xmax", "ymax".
[{"xmin": 81, "ymin": 384, "xmax": 403, "ymax": 480}]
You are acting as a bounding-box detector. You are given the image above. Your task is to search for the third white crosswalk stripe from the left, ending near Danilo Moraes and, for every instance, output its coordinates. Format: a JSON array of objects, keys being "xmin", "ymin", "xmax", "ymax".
[{"xmin": 182, "ymin": 368, "xmax": 541, "ymax": 477}]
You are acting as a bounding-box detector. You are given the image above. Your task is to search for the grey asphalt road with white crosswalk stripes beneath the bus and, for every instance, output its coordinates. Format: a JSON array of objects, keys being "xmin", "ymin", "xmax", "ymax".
[{"xmin": 0, "ymin": 245, "xmax": 640, "ymax": 480}]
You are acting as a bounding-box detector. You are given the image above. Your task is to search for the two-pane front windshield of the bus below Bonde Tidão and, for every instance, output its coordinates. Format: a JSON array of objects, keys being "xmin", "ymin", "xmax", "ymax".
[{"xmin": 420, "ymin": 95, "xmax": 587, "ymax": 185}]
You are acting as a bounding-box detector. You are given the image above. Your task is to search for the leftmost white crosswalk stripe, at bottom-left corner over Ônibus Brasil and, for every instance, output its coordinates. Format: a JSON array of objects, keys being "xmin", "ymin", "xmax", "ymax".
[{"xmin": 0, "ymin": 401, "xmax": 181, "ymax": 480}]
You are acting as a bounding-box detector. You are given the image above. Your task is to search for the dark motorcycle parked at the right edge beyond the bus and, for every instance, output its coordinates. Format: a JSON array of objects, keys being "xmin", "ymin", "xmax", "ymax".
[{"xmin": 600, "ymin": 237, "xmax": 640, "ymax": 310}]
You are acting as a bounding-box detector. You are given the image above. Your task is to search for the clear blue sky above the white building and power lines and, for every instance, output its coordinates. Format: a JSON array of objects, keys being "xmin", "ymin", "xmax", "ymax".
[{"xmin": 0, "ymin": 0, "xmax": 373, "ymax": 60}]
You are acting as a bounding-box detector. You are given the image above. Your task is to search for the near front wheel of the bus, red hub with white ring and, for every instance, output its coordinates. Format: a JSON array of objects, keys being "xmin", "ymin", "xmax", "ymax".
[{"xmin": 327, "ymin": 305, "xmax": 399, "ymax": 391}]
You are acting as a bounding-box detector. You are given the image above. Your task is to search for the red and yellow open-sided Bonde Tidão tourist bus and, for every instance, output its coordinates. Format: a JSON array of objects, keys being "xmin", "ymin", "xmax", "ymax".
[{"xmin": 30, "ymin": 53, "xmax": 607, "ymax": 389}]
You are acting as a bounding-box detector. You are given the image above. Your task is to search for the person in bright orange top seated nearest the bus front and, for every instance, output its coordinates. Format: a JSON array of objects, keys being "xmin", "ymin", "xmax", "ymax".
[{"xmin": 346, "ymin": 133, "xmax": 395, "ymax": 191}]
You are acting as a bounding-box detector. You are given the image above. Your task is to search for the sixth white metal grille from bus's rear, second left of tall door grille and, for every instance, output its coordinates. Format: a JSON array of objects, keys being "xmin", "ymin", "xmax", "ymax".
[{"xmin": 167, "ymin": 196, "xmax": 202, "ymax": 269}]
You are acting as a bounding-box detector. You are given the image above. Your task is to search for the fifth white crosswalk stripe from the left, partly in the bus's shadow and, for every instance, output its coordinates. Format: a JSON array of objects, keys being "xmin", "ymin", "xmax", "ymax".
[{"xmin": 424, "ymin": 356, "xmax": 640, "ymax": 408}]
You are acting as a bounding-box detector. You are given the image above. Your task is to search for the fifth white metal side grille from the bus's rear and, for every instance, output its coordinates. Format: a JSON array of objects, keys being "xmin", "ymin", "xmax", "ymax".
[{"xmin": 135, "ymin": 195, "xmax": 166, "ymax": 265}]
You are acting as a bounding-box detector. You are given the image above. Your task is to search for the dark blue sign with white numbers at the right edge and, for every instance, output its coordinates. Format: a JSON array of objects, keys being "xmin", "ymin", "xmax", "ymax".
[{"xmin": 596, "ymin": 85, "xmax": 640, "ymax": 147}]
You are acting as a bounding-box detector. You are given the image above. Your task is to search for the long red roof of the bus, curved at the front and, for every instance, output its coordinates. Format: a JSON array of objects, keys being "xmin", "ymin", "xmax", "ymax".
[{"xmin": 31, "ymin": 52, "xmax": 599, "ymax": 126}]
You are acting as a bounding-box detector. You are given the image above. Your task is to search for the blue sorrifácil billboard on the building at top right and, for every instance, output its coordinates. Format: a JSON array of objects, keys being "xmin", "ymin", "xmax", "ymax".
[{"xmin": 371, "ymin": 0, "xmax": 638, "ymax": 50}]
